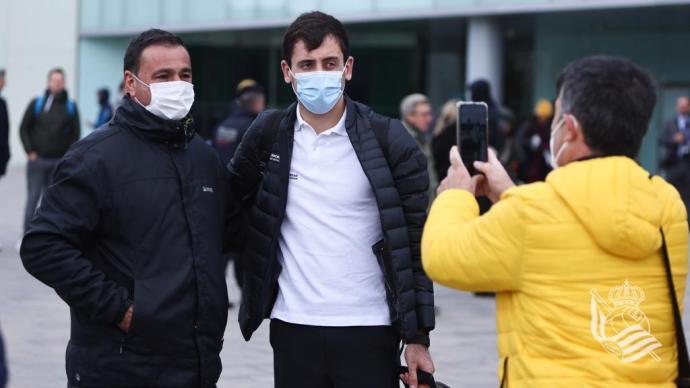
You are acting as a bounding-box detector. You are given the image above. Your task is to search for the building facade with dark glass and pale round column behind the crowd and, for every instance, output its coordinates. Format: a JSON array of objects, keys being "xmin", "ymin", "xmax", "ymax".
[{"xmin": 0, "ymin": 0, "xmax": 690, "ymax": 171}]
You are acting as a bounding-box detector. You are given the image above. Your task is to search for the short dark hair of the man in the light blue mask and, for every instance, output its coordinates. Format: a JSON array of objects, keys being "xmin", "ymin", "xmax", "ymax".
[{"xmin": 283, "ymin": 11, "xmax": 350, "ymax": 65}]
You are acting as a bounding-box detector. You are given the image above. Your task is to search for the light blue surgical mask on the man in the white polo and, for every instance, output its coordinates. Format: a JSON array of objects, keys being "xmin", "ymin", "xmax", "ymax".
[{"xmin": 290, "ymin": 67, "xmax": 347, "ymax": 115}]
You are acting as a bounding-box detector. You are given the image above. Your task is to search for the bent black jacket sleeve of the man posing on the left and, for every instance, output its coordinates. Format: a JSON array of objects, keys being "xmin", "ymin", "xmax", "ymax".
[{"xmin": 20, "ymin": 155, "xmax": 129, "ymax": 325}]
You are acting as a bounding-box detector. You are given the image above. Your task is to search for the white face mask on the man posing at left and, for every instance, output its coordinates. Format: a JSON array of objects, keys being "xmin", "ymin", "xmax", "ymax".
[{"xmin": 132, "ymin": 74, "xmax": 194, "ymax": 120}]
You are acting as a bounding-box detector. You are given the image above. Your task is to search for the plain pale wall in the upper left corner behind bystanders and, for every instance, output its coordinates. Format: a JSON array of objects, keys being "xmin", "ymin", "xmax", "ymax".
[{"xmin": 0, "ymin": 0, "xmax": 79, "ymax": 165}]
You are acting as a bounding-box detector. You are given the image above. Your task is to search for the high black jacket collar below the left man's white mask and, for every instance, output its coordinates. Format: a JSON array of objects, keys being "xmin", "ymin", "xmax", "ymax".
[{"xmin": 111, "ymin": 95, "xmax": 196, "ymax": 148}]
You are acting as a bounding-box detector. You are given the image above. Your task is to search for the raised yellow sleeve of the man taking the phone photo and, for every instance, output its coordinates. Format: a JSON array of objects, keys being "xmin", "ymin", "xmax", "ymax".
[{"xmin": 422, "ymin": 190, "xmax": 524, "ymax": 291}]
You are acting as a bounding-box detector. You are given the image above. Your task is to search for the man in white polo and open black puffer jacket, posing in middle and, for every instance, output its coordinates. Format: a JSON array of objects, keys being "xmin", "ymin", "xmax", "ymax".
[{"xmin": 230, "ymin": 12, "xmax": 434, "ymax": 388}]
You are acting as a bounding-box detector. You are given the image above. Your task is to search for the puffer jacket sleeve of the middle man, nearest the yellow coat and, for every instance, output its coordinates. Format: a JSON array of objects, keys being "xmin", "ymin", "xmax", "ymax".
[{"xmin": 388, "ymin": 120, "xmax": 435, "ymax": 332}]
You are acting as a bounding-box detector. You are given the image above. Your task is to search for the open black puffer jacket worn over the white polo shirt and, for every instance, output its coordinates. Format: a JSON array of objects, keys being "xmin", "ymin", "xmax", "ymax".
[{"xmin": 230, "ymin": 98, "xmax": 434, "ymax": 342}]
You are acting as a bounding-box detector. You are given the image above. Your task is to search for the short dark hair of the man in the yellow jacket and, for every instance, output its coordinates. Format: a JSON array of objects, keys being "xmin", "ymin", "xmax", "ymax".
[{"xmin": 556, "ymin": 56, "xmax": 656, "ymax": 158}]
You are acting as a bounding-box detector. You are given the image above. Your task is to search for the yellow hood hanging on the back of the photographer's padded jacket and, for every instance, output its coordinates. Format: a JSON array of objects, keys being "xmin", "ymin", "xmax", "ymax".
[{"xmin": 546, "ymin": 157, "xmax": 664, "ymax": 259}]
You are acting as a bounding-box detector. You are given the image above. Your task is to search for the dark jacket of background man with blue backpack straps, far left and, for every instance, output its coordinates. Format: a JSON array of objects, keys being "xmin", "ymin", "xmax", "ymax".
[{"xmin": 19, "ymin": 91, "xmax": 81, "ymax": 159}]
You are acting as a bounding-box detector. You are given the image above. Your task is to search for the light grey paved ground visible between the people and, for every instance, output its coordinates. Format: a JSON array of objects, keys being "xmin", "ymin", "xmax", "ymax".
[{"xmin": 0, "ymin": 168, "xmax": 690, "ymax": 388}]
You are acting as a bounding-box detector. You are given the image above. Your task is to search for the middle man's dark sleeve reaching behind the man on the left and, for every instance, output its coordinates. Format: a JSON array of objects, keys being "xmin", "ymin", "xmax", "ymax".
[{"xmin": 228, "ymin": 111, "xmax": 270, "ymax": 205}]
